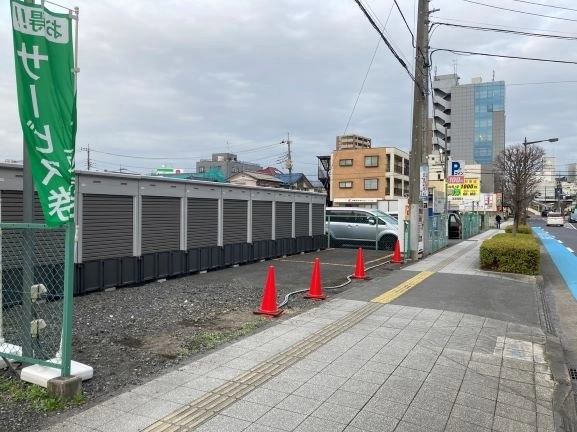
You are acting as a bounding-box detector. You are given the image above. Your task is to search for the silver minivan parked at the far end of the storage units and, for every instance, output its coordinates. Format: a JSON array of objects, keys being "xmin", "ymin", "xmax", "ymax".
[{"xmin": 325, "ymin": 207, "xmax": 399, "ymax": 251}]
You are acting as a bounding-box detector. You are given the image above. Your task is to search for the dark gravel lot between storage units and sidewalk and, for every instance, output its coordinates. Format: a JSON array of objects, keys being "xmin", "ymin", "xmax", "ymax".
[{"xmin": 0, "ymin": 250, "xmax": 392, "ymax": 432}]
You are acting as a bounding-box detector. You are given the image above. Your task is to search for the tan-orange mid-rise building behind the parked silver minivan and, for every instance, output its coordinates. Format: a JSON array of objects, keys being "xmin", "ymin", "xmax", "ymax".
[{"xmin": 330, "ymin": 136, "xmax": 409, "ymax": 207}]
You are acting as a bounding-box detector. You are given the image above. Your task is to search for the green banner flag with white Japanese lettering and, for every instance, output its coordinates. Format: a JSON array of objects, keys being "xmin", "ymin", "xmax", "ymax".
[{"xmin": 10, "ymin": 0, "xmax": 76, "ymax": 226}]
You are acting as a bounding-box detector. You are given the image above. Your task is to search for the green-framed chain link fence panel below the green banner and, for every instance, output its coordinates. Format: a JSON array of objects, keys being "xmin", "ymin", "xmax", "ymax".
[{"xmin": 0, "ymin": 223, "xmax": 71, "ymax": 369}]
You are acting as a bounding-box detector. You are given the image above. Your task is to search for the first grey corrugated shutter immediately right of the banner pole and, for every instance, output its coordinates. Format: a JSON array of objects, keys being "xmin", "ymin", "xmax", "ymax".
[{"xmin": 82, "ymin": 194, "xmax": 134, "ymax": 261}]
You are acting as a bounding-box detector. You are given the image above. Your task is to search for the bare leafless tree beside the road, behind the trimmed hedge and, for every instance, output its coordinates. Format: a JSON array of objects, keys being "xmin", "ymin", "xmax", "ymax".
[{"xmin": 495, "ymin": 144, "xmax": 545, "ymax": 235}]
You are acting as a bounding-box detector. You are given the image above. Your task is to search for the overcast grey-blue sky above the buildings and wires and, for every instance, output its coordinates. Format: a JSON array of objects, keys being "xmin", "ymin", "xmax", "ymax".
[{"xmin": 0, "ymin": 0, "xmax": 577, "ymax": 179}]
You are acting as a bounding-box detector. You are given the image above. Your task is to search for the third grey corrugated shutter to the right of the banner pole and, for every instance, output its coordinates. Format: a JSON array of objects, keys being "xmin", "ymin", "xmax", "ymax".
[{"xmin": 187, "ymin": 198, "xmax": 218, "ymax": 249}]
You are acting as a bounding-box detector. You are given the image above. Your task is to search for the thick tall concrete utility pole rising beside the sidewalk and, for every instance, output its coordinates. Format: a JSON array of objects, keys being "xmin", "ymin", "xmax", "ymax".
[{"xmin": 409, "ymin": 0, "xmax": 429, "ymax": 261}]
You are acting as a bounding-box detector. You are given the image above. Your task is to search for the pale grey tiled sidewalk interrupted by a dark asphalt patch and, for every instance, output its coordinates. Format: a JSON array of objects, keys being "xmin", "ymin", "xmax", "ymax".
[{"xmin": 42, "ymin": 230, "xmax": 568, "ymax": 432}]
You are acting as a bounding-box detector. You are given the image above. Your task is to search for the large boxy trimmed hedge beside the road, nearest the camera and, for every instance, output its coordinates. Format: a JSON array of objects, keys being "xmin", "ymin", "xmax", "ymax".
[{"xmin": 480, "ymin": 233, "xmax": 540, "ymax": 275}]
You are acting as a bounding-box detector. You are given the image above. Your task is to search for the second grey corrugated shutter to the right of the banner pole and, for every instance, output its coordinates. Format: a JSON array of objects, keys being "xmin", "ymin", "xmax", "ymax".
[{"xmin": 142, "ymin": 196, "xmax": 180, "ymax": 253}]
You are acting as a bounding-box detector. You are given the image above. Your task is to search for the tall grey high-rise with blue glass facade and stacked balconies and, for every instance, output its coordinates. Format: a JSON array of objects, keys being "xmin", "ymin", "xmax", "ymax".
[{"xmin": 432, "ymin": 74, "xmax": 505, "ymax": 193}]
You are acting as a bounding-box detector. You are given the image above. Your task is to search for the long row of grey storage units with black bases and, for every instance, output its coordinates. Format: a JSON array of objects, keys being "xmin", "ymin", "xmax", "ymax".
[{"xmin": 0, "ymin": 164, "xmax": 326, "ymax": 294}]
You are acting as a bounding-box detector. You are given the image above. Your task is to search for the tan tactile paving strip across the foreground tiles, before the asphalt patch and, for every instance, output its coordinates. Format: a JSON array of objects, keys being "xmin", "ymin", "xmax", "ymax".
[{"xmin": 144, "ymin": 303, "xmax": 381, "ymax": 432}]
